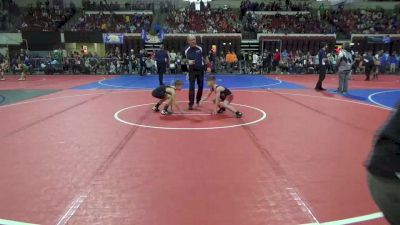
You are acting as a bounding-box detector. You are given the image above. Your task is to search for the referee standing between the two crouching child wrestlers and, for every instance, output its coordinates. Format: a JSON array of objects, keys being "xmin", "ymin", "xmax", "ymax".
[{"xmin": 185, "ymin": 35, "xmax": 205, "ymax": 110}]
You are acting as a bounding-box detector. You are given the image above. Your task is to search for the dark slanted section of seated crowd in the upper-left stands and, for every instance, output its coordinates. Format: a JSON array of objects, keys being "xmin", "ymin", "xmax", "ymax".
[{"xmin": 19, "ymin": 0, "xmax": 76, "ymax": 31}]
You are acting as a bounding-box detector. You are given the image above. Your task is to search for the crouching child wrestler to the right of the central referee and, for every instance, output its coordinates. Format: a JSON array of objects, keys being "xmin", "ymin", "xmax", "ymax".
[{"xmin": 201, "ymin": 76, "xmax": 243, "ymax": 118}]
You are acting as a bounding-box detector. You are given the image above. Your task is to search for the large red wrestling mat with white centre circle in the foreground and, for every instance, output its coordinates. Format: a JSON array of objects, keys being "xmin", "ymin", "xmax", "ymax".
[{"xmin": 0, "ymin": 90, "xmax": 389, "ymax": 225}]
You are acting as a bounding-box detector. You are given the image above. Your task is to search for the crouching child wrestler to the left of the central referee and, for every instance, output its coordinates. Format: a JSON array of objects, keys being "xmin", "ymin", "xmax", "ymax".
[{"xmin": 152, "ymin": 80, "xmax": 183, "ymax": 115}]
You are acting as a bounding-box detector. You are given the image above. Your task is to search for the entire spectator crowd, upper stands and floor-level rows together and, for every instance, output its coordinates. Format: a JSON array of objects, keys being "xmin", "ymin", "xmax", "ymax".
[{"xmin": 0, "ymin": 0, "xmax": 400, "ymax": 77}]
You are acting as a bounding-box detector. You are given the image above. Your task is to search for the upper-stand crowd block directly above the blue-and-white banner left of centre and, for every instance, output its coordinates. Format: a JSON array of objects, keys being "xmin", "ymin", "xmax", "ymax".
[{"xmin": 71, "ymin": 12, "xmax": 152, "ymax": 33}]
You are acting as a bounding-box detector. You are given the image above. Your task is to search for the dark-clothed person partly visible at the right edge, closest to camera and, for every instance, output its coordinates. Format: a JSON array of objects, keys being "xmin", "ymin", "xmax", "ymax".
[{"xmin": 366, "ymin": 104, "xmax": 400, "ymax": 225}]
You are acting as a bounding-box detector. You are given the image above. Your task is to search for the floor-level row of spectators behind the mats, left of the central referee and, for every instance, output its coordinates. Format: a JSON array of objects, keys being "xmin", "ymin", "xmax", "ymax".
[{"xmin": 0, "ymin": 47, "xmax": 182, "ymax": 75}]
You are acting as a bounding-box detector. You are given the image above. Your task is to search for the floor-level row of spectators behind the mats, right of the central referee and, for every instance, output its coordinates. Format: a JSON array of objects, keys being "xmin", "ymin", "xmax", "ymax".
[{"xmin": 200, "ymin": 46, "xmax": 400, "ymax": 74}]
